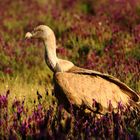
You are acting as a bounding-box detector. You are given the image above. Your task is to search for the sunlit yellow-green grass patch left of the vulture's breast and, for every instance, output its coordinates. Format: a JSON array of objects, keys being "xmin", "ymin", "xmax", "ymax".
[{"xmin": 0, "ymin": 67, "xmax": 53, "ymax": 110}]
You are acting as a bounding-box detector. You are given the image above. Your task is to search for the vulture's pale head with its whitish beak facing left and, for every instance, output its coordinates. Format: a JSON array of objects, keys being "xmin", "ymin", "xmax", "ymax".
[{"xmin": 25, "ymin": 25, "xmax": 54, "ymax": 40}]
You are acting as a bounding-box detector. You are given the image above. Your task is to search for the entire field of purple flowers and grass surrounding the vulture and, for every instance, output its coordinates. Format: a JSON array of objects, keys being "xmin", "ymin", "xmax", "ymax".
[{"xmin": 0, "ymin": 0, "xmax": 140, "ymax": 139}]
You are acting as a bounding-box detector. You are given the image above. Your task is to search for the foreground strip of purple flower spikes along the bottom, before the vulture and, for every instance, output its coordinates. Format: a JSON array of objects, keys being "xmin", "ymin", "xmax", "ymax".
[{"xmin": 0, "ymin": 92, "xmax": 140, "ymax": 139}]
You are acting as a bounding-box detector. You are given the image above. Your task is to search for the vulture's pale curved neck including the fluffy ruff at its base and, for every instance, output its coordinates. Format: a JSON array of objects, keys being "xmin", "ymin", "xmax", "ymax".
[{"xmin": 43, "ymin": 36, "xmax": 74, "ymax": 72}]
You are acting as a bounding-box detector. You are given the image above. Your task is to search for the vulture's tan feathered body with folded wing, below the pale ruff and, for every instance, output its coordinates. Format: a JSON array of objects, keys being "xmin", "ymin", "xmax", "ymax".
[{"xmin": 55, "ymin": 66, "xmax": 139, "ymax": 112}]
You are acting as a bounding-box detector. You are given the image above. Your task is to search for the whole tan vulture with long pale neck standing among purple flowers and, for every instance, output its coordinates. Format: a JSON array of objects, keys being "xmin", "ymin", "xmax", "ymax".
[{"xmin": 25, "ymin": 25, "xmax": 139, "ymax": 114}]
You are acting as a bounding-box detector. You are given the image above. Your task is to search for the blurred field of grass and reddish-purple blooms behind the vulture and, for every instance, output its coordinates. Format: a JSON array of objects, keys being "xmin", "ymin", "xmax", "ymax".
[{"xmin": 0, "ymin": 0, "xmax": 140, "ymax": 104}]
